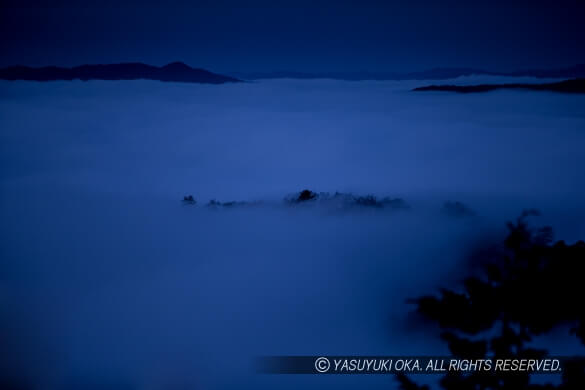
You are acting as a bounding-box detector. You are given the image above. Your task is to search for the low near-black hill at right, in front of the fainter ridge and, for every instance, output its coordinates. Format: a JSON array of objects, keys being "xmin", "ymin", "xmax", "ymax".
[{"xmin": 413, "ymin": 78, "xmax": 585, "ymax": 93}]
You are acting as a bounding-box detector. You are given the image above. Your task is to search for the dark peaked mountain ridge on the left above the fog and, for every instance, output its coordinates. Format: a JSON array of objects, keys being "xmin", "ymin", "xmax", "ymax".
[{"xmin": 0, "ymin": 62, "xmax": 241, "ymax": 84}]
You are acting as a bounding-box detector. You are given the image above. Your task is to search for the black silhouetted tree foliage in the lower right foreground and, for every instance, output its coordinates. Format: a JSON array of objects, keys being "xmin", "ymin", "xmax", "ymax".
[{"xmin": 397, "ymin": 210, "xmax": 585, "ymax": 390}]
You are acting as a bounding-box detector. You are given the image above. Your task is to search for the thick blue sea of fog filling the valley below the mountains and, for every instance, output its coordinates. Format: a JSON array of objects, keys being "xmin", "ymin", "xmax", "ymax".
[{"xmin": 0, "ymin": 76, "xmax": 585, "ymax": 389}]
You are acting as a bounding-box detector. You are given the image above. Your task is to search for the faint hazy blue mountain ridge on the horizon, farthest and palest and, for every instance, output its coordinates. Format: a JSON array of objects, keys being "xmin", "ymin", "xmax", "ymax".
[{"xmin": 233, "ymin": 64, "xmax": 585, "ymax": 81}]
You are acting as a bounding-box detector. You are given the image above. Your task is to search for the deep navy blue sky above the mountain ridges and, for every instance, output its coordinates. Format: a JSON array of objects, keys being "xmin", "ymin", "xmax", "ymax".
[{"xmin": 0, "ymin": 0, "xmax": 585, "ymax": 72}]
